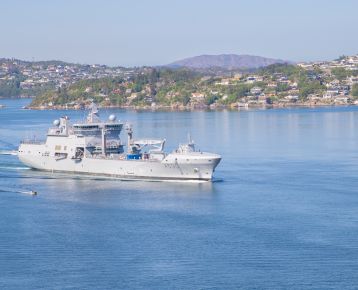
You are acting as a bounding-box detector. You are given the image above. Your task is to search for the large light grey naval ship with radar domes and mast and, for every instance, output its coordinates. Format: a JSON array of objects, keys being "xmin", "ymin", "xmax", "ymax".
[{"xmin": 17, "ymin": 104, "xmax": 221, "ymax": 181}]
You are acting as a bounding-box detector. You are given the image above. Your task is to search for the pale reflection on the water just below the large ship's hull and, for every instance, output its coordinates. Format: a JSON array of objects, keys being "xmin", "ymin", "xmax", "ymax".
[{"xmin": 13, "ymin": 170, "xmax": 220, "ymax": 211}]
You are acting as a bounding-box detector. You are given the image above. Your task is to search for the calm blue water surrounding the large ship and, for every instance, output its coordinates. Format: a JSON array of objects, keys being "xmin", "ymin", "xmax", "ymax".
[{"xmin": 0, "ymin": 100, "xmax": 358, "ymax": 289}]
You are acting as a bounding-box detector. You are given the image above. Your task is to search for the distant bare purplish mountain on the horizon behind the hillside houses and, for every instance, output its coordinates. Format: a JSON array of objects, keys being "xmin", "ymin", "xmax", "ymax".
[{"xmin": 166, "ymin": 54, "xmax": 291, "ymax": 69}]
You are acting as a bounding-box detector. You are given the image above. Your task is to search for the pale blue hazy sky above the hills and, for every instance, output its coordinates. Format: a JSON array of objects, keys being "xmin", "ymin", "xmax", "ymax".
[{"xmin": 0, "ymin": 0, "xmax": 358, "ymax": 66}]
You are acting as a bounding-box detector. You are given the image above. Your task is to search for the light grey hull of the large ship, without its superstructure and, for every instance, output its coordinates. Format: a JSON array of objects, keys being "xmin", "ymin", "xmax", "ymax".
[{"xmin": 18, "ymin": 144, "xmax": 221, "ymax": 181}]
